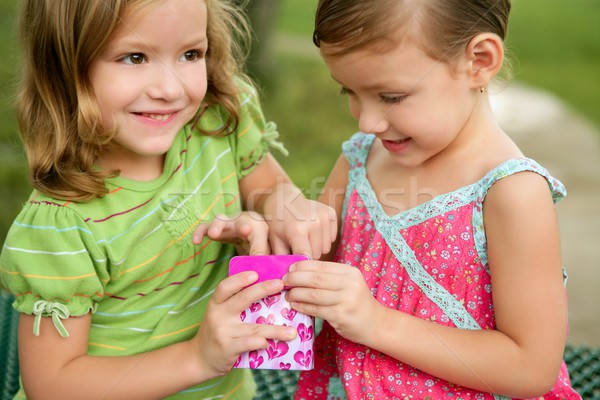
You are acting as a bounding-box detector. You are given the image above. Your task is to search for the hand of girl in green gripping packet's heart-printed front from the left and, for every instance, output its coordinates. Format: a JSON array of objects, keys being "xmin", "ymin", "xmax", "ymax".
[{"xmin": 192, "ymin": 271, "xmax": 296, "ymax": 377}]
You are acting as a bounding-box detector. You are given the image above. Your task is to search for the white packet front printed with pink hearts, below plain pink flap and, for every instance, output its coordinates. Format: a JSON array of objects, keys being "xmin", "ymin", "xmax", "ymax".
[{"xmin": 233, "ymin": 290, "xmax": 315, "ymax": 370}]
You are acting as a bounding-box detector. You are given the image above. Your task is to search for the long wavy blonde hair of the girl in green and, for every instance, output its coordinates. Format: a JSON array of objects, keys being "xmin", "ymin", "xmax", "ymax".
[{"xmin": 18, "ymin": 0, "xmax": 250, "ymax": 201}]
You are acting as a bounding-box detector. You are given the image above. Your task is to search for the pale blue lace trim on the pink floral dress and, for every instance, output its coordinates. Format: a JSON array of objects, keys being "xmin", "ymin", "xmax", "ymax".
[{"xmin": 343, "ymin": 133, "xmax": 566, "ymax": 400}]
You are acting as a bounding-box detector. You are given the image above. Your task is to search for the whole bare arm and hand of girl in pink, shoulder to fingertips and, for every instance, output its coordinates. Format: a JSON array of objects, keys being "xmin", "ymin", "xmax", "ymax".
[{"xmin": 284, "ymin": 173, "xmax": 567, "ymax": 398}]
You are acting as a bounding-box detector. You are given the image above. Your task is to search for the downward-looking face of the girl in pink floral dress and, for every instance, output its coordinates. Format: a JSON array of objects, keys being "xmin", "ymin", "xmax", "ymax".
[{"xmin": 324, "ymin": 41, "xmax": 480, "ymax": 167}]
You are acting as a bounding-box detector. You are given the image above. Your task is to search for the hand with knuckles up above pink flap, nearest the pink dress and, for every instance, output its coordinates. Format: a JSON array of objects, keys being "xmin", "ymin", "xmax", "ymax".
[{"xmin": 264, "ymin": 185, "xmax": 338, "ymax": 259}]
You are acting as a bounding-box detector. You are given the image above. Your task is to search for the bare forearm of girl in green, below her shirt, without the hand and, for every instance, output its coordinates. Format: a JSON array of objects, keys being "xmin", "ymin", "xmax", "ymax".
[{"xmin": 21, "ymin": 342, "xmax": 211, "ymax": 400}]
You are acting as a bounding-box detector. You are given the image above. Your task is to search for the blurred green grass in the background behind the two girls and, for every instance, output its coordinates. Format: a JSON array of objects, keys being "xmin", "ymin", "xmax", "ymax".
[{"xmin": 0, "ymin": 0, "xmax": 600, "ymax": 242}]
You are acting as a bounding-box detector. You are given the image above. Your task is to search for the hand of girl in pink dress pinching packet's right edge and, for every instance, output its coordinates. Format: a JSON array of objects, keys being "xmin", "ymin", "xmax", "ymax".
[{"xmin": 283, "ymin": 261, "xmax": 384, "ymax": 344}]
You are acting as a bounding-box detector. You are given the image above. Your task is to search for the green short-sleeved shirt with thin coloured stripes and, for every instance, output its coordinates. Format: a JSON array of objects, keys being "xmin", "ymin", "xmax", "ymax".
[{"xmin": 0, "ymin": 82, "xmax": 276, "ymax": 399}]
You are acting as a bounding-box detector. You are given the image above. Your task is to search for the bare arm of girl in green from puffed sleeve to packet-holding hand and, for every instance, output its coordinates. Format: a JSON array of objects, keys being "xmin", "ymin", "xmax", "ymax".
[{"xmin": 19, "ymin": 272, "xmax": 295, "ymax": 400}]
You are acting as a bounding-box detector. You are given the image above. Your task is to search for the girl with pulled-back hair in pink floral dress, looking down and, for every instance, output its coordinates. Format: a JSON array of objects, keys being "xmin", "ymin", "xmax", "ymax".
[{"xmin": 284, "ymin": 0, "xmax": 580, "ymax": 399}]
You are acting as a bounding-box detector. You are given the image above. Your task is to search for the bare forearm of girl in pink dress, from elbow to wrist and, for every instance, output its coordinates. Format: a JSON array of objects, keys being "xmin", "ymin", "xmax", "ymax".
[{"xmin": 363, "ymin": 306, "xmax": 562, "ymax": 398}]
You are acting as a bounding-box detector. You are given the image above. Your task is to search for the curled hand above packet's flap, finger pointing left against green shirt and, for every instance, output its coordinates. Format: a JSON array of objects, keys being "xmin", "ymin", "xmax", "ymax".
[{"xmin": 192, "ymin": 211, "xmax": 271, "ymax": 255}]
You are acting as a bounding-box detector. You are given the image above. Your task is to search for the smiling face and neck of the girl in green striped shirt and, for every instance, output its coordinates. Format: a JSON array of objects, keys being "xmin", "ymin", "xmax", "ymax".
[{"xmin": 91, "ymin": 0, "xmax": 208, "ymax": 180}]
